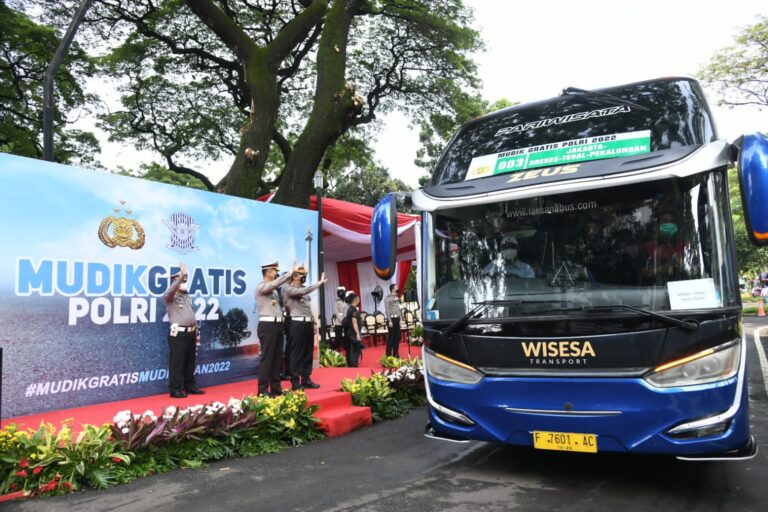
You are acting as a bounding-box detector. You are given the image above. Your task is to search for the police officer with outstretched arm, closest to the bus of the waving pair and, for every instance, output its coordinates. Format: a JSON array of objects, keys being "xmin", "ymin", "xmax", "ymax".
[{"xmin": 283, "ymin": 265, "xmax": 327, "ymax": 390}]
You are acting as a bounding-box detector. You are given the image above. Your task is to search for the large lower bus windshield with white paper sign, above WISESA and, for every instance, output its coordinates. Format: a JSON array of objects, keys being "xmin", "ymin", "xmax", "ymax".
[{"xmin": 427, "ymin": 169, "xmax": 737, "ymax": 320}]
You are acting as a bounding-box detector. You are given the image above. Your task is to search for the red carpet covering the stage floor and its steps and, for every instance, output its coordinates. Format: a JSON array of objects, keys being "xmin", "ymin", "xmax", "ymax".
[{"xmin": 2, "ymin": 343, "xmax": 421, "ymax": 437}]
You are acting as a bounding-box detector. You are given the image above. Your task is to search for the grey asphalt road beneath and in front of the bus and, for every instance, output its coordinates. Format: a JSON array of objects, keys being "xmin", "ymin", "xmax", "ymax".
[{"xmin": 3, "ymin": 318, "xmax": 768, "ymax": 512}]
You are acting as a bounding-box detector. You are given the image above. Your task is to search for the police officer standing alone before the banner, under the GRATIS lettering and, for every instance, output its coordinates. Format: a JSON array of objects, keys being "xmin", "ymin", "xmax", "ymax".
[{"xmin": 163, "ymin": 263, "xmax": 205, "ymax": 398}]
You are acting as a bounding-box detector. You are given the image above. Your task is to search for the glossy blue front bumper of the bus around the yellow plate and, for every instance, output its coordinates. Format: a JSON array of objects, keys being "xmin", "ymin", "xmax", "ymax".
[{"xmin": 426, "ymin": 367, "xmax": 757, "ymax": 460}]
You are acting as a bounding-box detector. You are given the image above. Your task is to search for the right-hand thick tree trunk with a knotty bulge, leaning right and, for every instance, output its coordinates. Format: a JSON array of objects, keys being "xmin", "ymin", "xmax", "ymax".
[{"xmin": 273, "ymin": 0, "xmax": 362, "ymax": 208}]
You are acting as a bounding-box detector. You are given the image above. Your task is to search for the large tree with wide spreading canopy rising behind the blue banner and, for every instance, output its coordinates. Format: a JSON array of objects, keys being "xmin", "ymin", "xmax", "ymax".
[{"xmin": 37, "ymin": 0, "xmax": 480, "ymax": 206}]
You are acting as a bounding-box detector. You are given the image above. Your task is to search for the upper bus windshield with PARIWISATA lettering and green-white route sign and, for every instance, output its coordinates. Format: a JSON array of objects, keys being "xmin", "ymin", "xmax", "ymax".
[{"xmin": 432, "ymin": 78, "xmax": 716, "ymax": 185}]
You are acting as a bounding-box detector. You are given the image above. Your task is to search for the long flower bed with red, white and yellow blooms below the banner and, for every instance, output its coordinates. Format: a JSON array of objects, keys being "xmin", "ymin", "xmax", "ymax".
[{"xmin": 0, "ymin": 392, "xmax": 323, "ymax": 495}]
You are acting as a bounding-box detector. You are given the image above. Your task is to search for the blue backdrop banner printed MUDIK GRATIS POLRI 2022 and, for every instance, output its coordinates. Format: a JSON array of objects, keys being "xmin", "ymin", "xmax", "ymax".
[{"xmin": 0, "ymin": 153, "xmax": 317, "ymax": 418}]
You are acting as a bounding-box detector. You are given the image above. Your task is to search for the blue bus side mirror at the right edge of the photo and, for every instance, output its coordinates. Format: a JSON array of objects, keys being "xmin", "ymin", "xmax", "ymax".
[{"xmin": 738, "ymin": 133, "xmax": 768, "ymax": 245}]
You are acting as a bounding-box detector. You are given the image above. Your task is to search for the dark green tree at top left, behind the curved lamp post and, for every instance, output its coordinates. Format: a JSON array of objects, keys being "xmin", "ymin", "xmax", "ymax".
[{"xmin": 0, "ymin": 0, "xmax": 99, "ymax": 164}]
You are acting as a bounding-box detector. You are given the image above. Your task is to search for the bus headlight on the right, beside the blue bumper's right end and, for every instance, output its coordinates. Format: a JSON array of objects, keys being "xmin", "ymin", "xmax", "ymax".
[{"xmin": 645, "ymin": 340, "xmax": 741, "ymax": 388}]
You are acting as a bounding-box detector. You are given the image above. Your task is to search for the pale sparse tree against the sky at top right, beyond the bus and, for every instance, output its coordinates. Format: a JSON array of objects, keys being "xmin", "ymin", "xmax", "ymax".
[{"xmin": 699, "ymin": 16, "xmax": 768, "ymax": 107}]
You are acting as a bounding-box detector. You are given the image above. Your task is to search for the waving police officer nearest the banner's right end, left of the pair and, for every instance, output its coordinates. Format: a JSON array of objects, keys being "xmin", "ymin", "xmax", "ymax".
[{"xmin": 254, "ymin": 261, "xmax": 296, "ymax": 396}]
